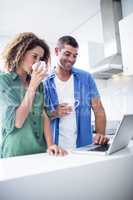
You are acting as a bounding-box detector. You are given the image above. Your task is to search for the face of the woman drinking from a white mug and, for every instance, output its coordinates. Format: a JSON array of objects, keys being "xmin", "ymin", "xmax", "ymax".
[{"xmin": 22, "ymin": 46, "xmax": 44, "ymax": 73}]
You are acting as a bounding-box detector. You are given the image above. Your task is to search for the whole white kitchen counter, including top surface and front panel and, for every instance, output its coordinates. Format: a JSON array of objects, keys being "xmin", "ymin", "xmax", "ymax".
[{"xmin": 0, "ymin": 141, "xmax": 133, "ymax": 200}]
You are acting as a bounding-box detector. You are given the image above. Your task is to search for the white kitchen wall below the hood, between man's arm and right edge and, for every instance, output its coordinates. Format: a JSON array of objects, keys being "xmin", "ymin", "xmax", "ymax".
[{"xmin": 96, "ymin": 76, "xmax": 133, "ymax": 120}]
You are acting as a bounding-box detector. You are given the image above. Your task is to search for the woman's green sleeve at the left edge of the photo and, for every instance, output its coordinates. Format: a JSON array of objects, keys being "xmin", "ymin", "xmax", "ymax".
[{"xmin": 0, "ymin": 76, "xmax": 19, "ymax": 134}]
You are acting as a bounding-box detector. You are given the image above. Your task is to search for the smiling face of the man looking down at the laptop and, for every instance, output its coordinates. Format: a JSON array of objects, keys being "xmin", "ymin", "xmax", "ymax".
[{"xmin": 55, "ymin": 44, "xmax": 78, "ymax": 71}]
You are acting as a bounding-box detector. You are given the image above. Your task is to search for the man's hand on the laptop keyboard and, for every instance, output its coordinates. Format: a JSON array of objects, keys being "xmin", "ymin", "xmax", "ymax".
[{"xmin": 93, "ymin": 133, "xmax": 109, "ymax": 144}]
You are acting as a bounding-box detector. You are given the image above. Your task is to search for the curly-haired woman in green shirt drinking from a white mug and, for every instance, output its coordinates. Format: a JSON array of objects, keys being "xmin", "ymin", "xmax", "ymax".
[{"xmin": 0, "ymin": 33, "xmax": 65, "ymax": 158}]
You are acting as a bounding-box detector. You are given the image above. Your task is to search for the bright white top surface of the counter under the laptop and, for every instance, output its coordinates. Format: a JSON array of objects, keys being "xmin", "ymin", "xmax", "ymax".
[{"xmin": 0, "ymin": 141, "xmax": 133, "ymax": 181}]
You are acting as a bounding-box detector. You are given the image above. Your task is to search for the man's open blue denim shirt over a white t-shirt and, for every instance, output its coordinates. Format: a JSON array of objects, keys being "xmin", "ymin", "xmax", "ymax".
[{"xmin": 43, "ymin": 68, "xmax": 100, "ymax": 147}]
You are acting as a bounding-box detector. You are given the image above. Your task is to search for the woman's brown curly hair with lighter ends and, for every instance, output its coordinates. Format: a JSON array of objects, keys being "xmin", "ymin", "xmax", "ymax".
[{"xmin": 2, "ymin": 32, "xmax": 50, "ymax": 71}]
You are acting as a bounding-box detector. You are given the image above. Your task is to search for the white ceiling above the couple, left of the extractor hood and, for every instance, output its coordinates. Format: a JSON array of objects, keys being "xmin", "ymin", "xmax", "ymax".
[{"xmin": 0, "ymin": 0, "xmax": 103, "ymax": 45}]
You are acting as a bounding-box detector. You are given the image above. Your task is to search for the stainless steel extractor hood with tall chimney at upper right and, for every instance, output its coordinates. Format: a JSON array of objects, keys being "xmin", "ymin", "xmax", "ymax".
[{"xmin": 90, "ymin": 0, "xmax": 123, "ymax": 79}]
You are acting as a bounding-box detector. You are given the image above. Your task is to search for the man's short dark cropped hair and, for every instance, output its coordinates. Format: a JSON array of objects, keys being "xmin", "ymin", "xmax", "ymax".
[{"xmin": 57, "ymin": 35, "xmax": 79, "ymax": 48}]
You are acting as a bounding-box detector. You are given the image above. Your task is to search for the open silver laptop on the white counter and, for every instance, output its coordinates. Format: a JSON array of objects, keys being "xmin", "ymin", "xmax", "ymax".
[{"xmin": 72, "ymin": 114, "xmax": 133, "ymax": 155}]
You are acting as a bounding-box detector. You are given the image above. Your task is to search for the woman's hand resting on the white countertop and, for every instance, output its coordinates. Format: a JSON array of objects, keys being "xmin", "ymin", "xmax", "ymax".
[{"xmin": 47, "ymin": 144, "xmax": 68, "ymax": 156}]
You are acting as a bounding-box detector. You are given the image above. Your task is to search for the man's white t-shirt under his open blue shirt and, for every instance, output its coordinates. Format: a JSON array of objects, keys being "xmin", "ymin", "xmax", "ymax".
[{"xmin": 55, "ymin": 75, "xmax": 77, "ymax": 149}]
